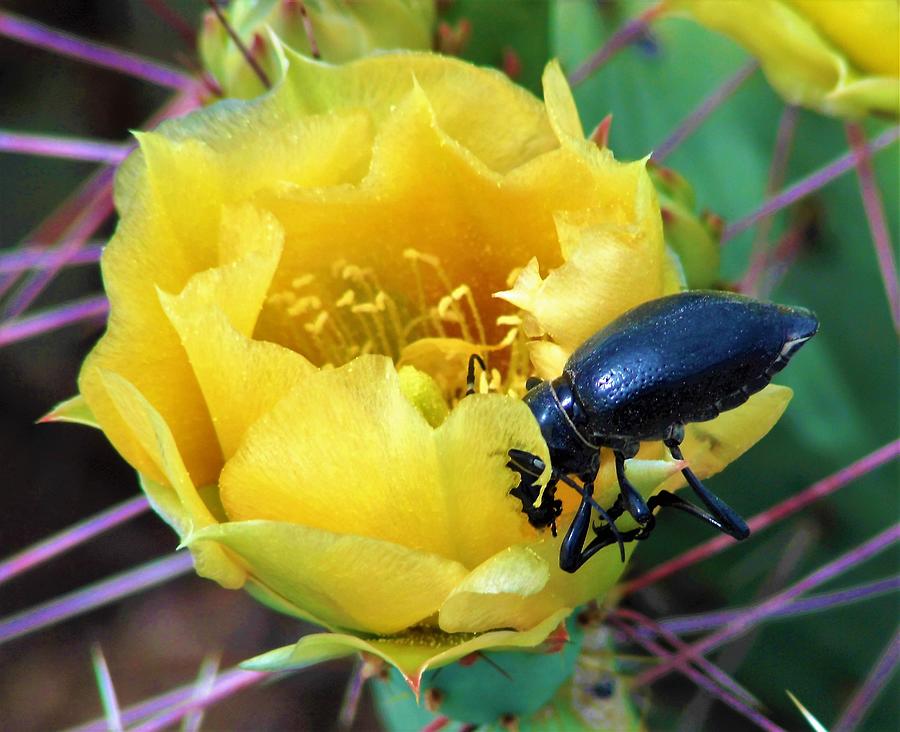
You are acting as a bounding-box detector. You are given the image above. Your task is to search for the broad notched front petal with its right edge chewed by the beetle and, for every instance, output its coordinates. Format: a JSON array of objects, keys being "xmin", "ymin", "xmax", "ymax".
[{"xmin": 221, "ymin": 356, "xmax": 549, "ymax": 567}]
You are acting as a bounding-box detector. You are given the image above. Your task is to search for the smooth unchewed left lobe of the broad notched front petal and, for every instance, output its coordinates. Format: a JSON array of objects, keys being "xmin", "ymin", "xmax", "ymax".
[{"xmin": 220, "ymin": 356, "xmax": 452, "ymax": 556}]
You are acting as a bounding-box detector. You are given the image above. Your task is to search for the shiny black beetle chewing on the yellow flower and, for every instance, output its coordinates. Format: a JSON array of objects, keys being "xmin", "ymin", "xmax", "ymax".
[{"xmin": 482, "ymin": 291, "xmax": 819, "ymax": 572}]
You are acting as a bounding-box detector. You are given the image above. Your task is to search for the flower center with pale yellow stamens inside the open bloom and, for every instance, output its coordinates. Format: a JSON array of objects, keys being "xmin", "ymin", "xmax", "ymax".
[{"xmin": 257, "ymin": 249, "xmax": 529, "ymax": 400}]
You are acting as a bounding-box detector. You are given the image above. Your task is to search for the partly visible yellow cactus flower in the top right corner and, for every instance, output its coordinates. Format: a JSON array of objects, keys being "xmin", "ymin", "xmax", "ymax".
[{"xmin": 664, "ymin": 0, "xmax": 900, "ymax": 117}]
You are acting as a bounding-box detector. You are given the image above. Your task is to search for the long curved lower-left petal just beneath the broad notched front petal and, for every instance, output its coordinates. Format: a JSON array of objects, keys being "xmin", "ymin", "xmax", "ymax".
[{"xmin": 186, "ymin": 521, "xmax": 466, "ymax": 633}]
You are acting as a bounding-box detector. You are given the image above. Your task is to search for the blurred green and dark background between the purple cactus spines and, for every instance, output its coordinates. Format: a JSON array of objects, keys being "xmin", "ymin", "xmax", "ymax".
[{"xmin": 0, "ymin": 0, "xmax": 900, "ymax": 730}]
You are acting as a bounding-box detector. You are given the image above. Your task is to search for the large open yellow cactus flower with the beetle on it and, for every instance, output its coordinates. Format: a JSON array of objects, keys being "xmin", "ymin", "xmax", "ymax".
[{"xmin": 54, "ymin": 49, "xmax": 788, "ymax": 685}]
